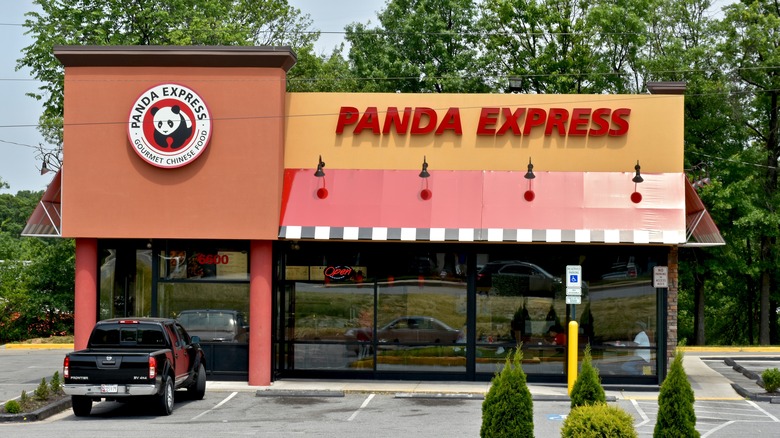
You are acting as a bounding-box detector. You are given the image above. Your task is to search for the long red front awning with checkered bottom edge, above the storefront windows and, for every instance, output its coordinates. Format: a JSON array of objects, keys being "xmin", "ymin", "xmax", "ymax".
[{"xmin": 279, "ymin": 169, "xmax": 695, "ymax": 245}]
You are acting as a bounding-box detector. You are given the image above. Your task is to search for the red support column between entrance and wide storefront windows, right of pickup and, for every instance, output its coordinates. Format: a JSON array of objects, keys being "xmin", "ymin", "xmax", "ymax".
[{"xmin": 249, "ymin": 240, "xmax": 274, "ymax": 386}]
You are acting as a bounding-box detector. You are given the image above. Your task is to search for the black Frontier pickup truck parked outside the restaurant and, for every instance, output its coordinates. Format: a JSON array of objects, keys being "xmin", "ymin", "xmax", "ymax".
[{"xmin": 62, "ymin": 318, "xmax": 206, "ymax": 417}]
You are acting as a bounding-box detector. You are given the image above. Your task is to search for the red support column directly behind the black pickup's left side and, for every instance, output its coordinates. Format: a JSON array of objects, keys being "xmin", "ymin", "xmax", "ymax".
[{"xmin": 73, "ymin": 239, "xmax": 98, "ymax": 350}]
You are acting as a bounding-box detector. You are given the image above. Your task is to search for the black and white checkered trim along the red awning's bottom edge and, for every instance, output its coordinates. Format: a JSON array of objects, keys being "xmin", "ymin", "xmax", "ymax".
[{"xmin": 279, "ymin": 225, "xmax": 685, "ymax": 245}]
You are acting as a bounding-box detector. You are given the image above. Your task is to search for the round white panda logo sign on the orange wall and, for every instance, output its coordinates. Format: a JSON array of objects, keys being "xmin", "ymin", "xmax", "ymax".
[{"xmin": 127, "ymin": 84, "xmax": 211, "ymax": 169}]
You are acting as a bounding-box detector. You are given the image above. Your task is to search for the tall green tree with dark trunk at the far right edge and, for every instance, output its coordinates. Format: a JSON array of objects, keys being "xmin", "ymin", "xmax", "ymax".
[{"xmin": 718, "ymin": 0, "xmax": 780, "ymax": 345}]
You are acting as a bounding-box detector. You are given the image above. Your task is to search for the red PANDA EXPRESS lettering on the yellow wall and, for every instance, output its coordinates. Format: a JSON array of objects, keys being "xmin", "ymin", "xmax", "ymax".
[{"xmin": 336, "ymin": 106, "xmax": 631, "ymax": 137}]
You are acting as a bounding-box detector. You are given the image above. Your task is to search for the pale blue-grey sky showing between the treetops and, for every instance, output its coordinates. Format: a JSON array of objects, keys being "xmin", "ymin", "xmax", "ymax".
[{"xmin": 0, "ymin": 0, "xmax": 731, "ymax": 194}]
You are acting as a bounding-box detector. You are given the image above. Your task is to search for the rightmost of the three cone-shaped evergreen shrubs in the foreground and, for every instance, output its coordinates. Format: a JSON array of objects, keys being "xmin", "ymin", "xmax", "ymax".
[{"xmin": 653, "ymin": 348, "xmax": 699, "ymax": 438}]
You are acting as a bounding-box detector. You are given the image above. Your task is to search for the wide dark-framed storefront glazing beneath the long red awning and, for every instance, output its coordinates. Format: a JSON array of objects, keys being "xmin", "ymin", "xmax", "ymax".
[{"xmin": 278, "ymin": 242, "xmax": 666, "ymax": 379}]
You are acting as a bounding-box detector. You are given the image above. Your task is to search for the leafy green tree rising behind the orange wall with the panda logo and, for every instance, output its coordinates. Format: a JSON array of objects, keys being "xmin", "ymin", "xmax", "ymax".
[{"xmin": 16, "ymin": 0, "xmax": 319, "ymax": 149}]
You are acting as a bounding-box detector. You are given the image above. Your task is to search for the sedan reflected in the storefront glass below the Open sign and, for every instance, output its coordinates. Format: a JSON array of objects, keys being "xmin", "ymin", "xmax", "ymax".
[{"xmin": 346, "ymin": 316, "xmax": 461, "ymax": 344}]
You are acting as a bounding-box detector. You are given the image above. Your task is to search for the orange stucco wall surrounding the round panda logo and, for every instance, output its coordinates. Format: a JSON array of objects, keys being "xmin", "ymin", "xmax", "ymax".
[{"xmin": 62, "ymin": 66, "xmax": 285, "ymax": 239}]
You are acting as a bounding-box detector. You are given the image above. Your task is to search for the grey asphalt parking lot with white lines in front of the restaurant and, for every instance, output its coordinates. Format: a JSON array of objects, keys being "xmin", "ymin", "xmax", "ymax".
[{"xmin": 0, "ymin": 348, "xmax": 780, "ymax": 437}]
